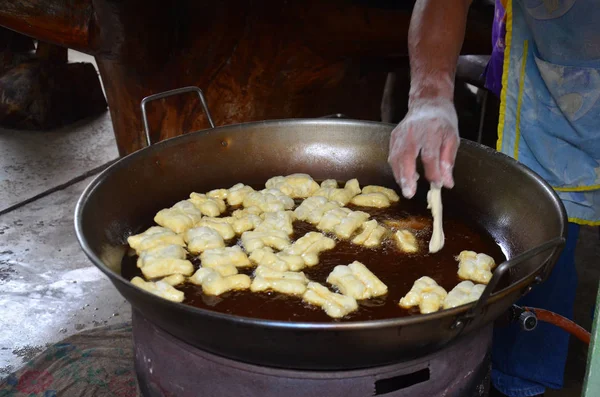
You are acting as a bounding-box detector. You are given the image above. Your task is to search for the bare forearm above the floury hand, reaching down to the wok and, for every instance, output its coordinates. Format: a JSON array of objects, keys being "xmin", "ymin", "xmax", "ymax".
[{"xmin": 408, "ymin": 0, "xmax": 471, "ymax": 106}]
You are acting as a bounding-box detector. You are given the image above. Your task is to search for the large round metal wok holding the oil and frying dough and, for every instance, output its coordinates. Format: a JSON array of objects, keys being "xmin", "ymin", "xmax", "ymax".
[{"xmin": 75, "ymin": 88, "xmax": 566, "ymax": 370}]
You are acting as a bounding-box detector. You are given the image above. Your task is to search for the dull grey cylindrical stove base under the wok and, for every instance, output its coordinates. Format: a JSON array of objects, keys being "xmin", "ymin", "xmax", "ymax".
[{"xmin": 133, "ymin": 311, "xmax": 492, "ymax": 397}]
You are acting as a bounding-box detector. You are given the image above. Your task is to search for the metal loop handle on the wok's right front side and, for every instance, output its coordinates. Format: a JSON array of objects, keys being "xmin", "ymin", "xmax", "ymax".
[{"xmin": 452, "ymin": 237, "xmax": 565, "ymax": 329}]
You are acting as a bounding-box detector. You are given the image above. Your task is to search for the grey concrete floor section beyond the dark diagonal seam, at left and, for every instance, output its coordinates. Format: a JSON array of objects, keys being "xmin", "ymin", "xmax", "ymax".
[{"xmin": 0, "ymin": 51, "xmax": 119, "ymax": 214}]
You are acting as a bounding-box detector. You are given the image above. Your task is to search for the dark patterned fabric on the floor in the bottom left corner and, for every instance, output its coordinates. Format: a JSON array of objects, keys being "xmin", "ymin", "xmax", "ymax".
[{"xmin": 0, "ymin": 323, "xmax": 140, "ymax": 397}]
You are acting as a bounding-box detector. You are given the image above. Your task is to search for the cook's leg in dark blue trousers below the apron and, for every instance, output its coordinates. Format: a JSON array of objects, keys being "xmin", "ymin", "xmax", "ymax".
[{"xmin": 492, "ymin": 224, "xmax": 579, "ymax": 397}]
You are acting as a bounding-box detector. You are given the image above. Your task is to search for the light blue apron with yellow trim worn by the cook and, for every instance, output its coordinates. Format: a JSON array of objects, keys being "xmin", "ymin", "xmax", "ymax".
[{"xmin": 496, "ymin": 0, "xmax": 600, "ymax": 225}]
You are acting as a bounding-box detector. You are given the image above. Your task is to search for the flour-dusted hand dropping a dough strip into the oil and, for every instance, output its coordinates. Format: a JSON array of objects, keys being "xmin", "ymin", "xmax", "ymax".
[{"xmin": 388, "ymin": 97, "xmax": 460, "ymax": 198}]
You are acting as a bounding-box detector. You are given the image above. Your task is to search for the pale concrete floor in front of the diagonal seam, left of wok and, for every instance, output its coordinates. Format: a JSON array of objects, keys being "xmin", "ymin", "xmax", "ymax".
[{"xmin": 0, "ymin": 175, "xmax": 131, "ymax": 377}]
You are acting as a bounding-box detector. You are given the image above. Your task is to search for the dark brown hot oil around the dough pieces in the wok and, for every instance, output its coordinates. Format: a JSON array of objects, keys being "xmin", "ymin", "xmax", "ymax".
[{"xmin": 121, "ymin": 195, "xmax": 505, "ymax": 322}]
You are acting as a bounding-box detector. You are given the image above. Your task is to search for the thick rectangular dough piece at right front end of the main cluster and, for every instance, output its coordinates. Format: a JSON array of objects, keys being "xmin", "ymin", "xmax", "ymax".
[{"xmin": 327, "ymin": 261, "xmax": 388, "ymax": 300}]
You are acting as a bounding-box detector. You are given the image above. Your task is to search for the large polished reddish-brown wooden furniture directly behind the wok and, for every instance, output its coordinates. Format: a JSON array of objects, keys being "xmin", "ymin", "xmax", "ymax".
[{"xmin": 0, "ymin": 0, "xmax": 491, "ymax": 155}]
